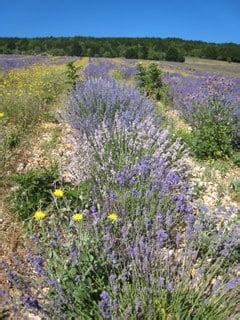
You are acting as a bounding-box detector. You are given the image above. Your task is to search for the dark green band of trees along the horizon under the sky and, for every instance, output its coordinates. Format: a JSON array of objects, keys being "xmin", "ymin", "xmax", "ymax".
[{"xmin": 0, "ymin": 37, "xmax": 240, "ymax": 62}]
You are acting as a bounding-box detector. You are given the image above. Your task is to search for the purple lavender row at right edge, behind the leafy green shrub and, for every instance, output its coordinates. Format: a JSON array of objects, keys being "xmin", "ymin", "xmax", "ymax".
[{"xmin": 163, "ymin": 71, "xmax": 240, "ymax": 122}]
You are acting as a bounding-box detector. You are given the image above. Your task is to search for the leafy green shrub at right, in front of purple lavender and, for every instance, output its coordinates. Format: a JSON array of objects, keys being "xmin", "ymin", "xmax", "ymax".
[{"xmin": 192, "ymin": 100, "xmax": 235, "ymax": 159}]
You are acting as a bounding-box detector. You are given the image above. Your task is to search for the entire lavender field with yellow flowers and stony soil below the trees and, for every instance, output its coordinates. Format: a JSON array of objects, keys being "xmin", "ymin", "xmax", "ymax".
[{"xmin": 0, "ymin": 56, "xmax": 240, "ymax": 320}]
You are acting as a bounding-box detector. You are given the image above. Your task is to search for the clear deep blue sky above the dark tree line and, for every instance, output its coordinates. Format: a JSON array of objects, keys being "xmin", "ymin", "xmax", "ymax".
[{"xmin": 0, "ymin": 0, "xmax": 240, "ymax": 43}]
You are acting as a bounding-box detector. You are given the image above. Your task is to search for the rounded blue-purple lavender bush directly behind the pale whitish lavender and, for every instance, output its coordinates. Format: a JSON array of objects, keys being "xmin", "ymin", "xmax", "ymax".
[{"xmin": 67, "ymin": 78, "xmax": 154, "ymax": 132}]
